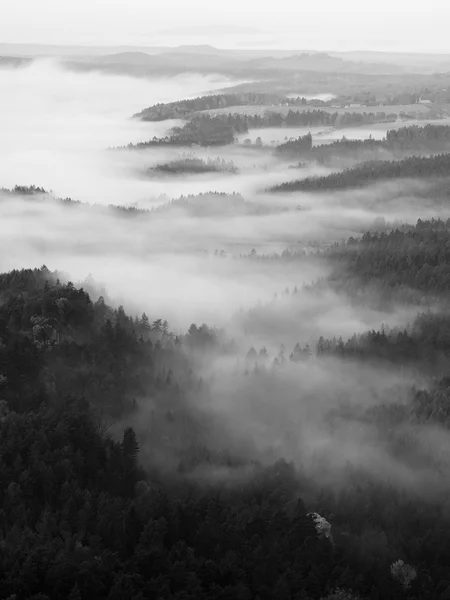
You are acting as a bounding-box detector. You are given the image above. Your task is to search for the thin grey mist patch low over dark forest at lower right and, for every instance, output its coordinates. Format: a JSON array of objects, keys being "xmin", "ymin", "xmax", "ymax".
[{"xmin": 200, "ymin": 359, "xmax": 432, "ymax": 483}]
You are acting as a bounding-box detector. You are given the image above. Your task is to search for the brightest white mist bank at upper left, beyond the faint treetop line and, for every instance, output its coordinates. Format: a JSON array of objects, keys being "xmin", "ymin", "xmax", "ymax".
[{"xmin": 0, "ymin": 60, "xmax": 241, "ymax": 204}]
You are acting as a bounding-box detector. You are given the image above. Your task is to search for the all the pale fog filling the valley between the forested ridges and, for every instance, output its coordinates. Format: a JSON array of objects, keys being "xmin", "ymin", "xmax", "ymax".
[{"xmin": 0, "ymin": 61, "xmax": 448, "ymax": 496}]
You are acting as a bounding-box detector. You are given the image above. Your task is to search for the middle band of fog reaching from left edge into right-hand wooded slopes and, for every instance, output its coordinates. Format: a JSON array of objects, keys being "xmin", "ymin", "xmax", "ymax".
[{"xmin": 0, "ymin": 176, "xmax": 434, "ymax": 347}]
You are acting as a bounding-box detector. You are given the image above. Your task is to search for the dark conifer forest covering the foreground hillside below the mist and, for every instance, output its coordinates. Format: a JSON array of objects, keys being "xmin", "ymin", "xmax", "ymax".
[{"xmin": 0, "ymin": 264, "xmax": 450, "ymax": 600}]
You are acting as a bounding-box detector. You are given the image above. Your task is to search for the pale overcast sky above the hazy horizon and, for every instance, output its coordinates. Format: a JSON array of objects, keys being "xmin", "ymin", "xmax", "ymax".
[{"xmin": 0, "ymin": 0, "xmax": 450, "ymax": 52}]
